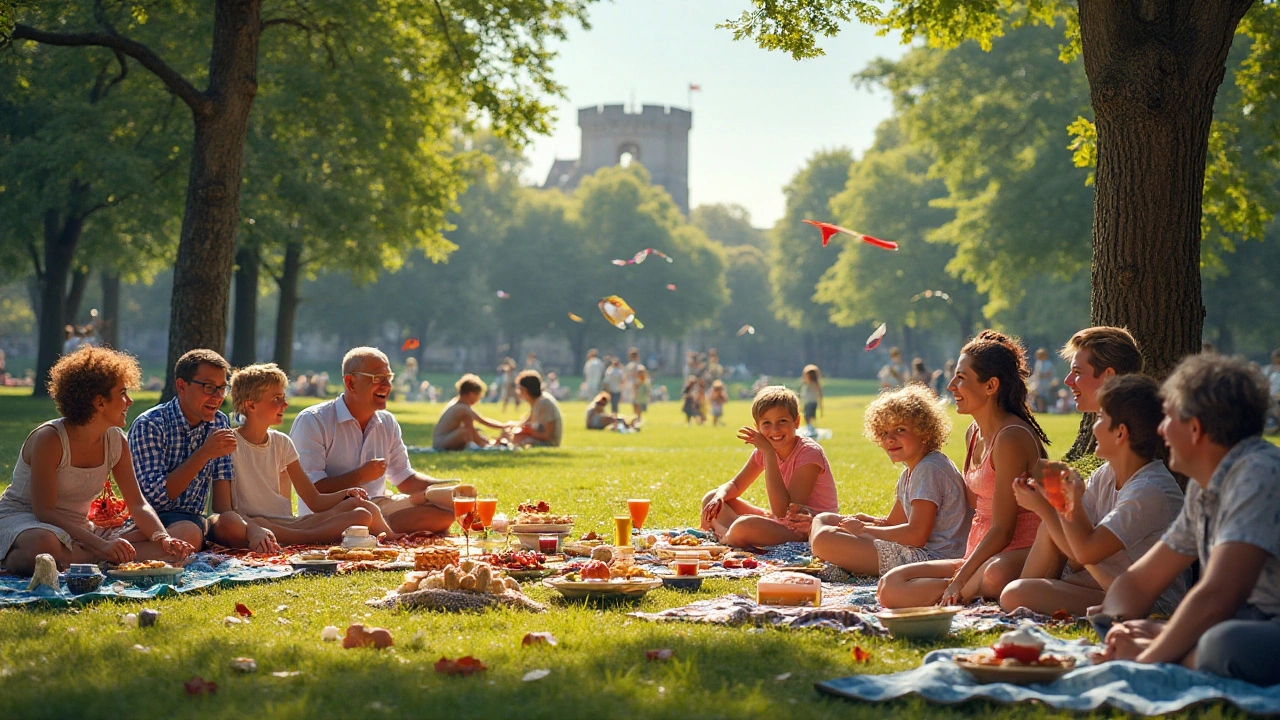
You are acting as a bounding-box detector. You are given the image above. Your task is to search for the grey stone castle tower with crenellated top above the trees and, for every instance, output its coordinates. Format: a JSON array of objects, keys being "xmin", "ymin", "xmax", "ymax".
[{"xmin": 543, "ymin": 105, "xmax": 694, "ymax": 217}]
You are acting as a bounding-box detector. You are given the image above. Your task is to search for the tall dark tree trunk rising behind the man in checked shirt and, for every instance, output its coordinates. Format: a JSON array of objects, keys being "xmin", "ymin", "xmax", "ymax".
[{"xmin": 164, "ymin": 0, "xmax": 261, "ymax": 400}]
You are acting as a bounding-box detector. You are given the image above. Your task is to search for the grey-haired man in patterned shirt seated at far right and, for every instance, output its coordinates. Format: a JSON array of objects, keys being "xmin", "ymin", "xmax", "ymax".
[{"xmin": 1089, "ymin": 354, "xmax": 1280, "ymax": 685}]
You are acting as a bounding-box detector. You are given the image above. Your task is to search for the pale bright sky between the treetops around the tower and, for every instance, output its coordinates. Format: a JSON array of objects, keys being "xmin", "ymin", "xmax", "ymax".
[{"xmin": 525, "ymin": 0, "xmax": 906, "ymax": 227}]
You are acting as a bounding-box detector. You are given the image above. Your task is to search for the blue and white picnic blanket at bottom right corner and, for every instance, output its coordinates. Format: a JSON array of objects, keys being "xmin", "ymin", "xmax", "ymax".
[{"xmin": 815, "ymin": 628, "xmax": 1280, "ymax": 715}]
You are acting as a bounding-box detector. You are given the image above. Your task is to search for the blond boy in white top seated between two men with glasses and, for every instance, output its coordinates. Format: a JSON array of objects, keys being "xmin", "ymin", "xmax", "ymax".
[{"xmin": 212, "ymin": 363, "xmax": 399, "ymax": 552}]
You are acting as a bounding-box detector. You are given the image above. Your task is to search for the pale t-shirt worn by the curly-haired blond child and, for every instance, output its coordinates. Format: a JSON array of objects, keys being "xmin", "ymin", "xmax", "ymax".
[{"xmin": 893, "ymin": 450, "xmax": 973, "ymax": 557}]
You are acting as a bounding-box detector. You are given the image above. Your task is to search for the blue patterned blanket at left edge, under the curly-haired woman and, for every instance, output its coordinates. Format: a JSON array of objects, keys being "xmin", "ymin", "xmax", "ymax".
[{"xmin": 0, "ymin": 553, "xmax": 294, "ymax": 609}]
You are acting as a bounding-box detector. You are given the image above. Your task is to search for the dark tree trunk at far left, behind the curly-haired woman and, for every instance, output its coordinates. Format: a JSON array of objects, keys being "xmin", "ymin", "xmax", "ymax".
[{"xmin": 32, "ymin": 193, "xmax": 88, "ymax": 397}]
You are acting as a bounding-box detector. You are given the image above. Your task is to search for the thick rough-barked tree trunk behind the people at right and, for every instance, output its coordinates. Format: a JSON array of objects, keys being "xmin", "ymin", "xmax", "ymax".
[{"xmin": 1069, "ymin": 0, "xmax": 1253, "ymax": 457}]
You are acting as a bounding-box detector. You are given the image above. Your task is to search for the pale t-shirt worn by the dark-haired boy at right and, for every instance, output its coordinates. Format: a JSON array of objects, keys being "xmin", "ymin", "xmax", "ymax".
[{"xmin": 1080, "ymin": 460, "xmax": 1187, "ymax": 603}]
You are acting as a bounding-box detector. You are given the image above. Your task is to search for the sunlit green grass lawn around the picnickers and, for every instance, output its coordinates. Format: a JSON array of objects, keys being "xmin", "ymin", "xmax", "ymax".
[{"xmin": 0, "ymin": 391, "xmax": 1239, "ymax": 720}]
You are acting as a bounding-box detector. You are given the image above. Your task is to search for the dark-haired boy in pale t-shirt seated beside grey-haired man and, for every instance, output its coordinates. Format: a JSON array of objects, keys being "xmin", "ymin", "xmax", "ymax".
[{"xmin": 1000, "ymin": 374, "xmax": 1187, "ymax": 616}]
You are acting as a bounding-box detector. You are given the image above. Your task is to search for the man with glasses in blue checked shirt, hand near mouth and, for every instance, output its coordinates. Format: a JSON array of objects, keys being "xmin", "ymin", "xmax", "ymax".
[{"xmin": 129, "ymin": 350, "xmax": 236, "ymax": 550}]
